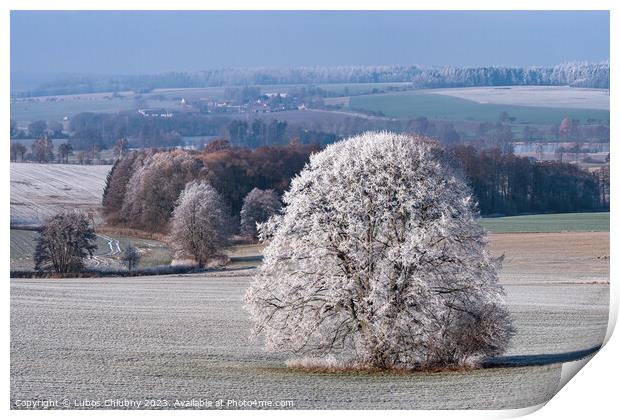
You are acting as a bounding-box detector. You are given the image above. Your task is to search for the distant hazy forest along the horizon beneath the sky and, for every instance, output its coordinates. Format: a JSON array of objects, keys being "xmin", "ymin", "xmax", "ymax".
[{"xmin": 11, "ymin": 62, "xmax": 609, "ymax": 97}]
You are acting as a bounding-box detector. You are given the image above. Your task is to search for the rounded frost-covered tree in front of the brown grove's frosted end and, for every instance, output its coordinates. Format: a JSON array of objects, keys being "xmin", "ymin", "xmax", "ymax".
[{"xmin": 170, "ymin": 181, "xmax": 231, "ymax": 267}]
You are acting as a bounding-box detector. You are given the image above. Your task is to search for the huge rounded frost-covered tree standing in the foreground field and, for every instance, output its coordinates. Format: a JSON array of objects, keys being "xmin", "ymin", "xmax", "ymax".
[{"xmin": 245, "ymin": 132, "xmax": 514, "ymax": 369}]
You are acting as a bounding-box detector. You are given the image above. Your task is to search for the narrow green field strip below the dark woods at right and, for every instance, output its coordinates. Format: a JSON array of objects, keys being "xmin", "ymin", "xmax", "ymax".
[{"xmin": 482, "ymin": 213, "xmax": 609, "ymax": 233}]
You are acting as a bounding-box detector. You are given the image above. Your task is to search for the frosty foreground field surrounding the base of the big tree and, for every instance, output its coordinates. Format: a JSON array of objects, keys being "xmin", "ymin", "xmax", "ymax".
[{"xmin": 10, "ymin": 233, "xmax": 609, "ymax": 409}]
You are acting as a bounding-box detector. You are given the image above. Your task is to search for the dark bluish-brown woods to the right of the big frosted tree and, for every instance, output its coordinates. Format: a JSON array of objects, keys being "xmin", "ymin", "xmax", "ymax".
[{"xmin": 451, "ymin": 146, "xmax": 609, "ymax": 215}]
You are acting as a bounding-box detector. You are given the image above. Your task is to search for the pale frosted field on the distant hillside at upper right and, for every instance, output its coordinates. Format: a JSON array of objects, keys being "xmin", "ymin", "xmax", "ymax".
[{"xmin": 429, "ymin": 86, "xmax": 609, "ymax": 110}]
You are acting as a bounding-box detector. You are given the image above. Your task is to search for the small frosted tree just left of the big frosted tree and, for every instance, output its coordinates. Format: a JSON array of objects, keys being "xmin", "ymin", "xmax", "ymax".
[{"xmin": 241, "ymin": 188, "xmax": 282, "ymax": 238}]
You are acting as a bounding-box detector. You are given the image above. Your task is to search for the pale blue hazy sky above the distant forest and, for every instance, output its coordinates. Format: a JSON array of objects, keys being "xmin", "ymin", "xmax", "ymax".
[{"xmin": 11, "ymin": 11, "xmax": 609, "ymax": 74}]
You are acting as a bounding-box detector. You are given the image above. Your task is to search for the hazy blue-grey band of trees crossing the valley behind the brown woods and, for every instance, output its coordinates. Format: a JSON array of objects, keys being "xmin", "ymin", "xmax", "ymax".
[{"xmin": 17, "ymin": 108, "xmax": 609, "ymax": 159}]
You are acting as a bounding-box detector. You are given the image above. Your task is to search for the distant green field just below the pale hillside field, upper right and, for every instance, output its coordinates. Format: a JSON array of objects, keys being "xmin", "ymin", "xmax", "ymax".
[{"xmin": 350, "ymin": 90, "xmax": 609, "ymax": 125}]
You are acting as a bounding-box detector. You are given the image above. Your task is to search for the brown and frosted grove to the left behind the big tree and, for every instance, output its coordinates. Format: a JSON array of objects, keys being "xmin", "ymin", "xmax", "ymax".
[{"xmin": 102, "ymin": 141, "xmax": 318, "ymax": 232}]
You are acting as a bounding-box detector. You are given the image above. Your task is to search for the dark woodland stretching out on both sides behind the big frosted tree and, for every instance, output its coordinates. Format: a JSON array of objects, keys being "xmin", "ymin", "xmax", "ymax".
[{"xmin": 102, "ymin": 140, "xmax": 609, "ymax": 232}]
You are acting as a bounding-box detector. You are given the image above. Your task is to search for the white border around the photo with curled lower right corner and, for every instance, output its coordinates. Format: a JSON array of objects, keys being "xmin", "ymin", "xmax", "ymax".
[{"xmin": 0, "ymin": 0, "xmax": 620, "ymax": 419}]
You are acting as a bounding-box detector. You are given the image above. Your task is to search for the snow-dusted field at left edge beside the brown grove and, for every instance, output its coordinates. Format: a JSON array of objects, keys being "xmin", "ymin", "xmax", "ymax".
[{"xmin": 11, "ymin": 163, "xmax": 111, "ymax": 224}]
